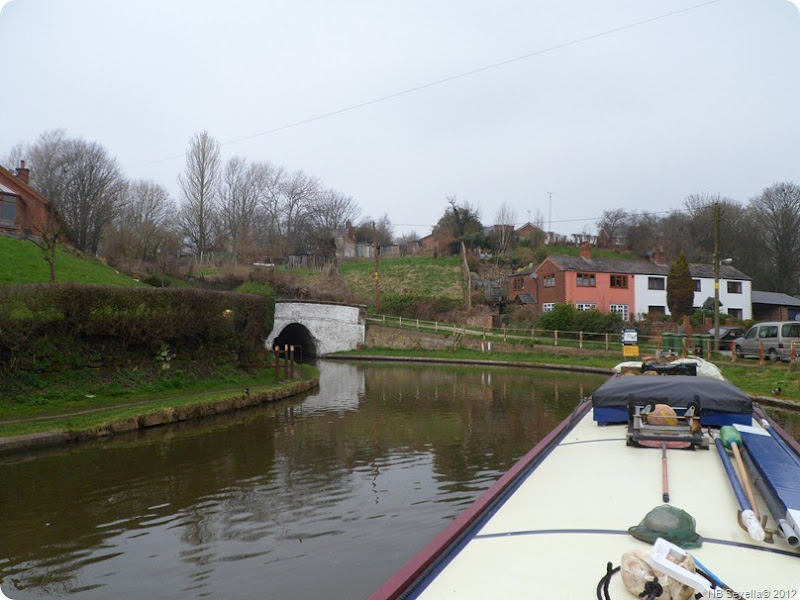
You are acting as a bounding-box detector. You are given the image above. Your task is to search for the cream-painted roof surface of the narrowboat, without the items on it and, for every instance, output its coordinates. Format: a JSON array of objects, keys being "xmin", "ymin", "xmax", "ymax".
[{"xmin": 372, "ymin": 405, "xmax": 800, "ymax": 600}]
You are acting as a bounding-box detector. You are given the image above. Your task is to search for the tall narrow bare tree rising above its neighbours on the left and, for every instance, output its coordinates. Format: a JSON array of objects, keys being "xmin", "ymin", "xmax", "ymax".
[{"xmin": 178, "ymin": 131, "xmax": 220, "ymax": 261}]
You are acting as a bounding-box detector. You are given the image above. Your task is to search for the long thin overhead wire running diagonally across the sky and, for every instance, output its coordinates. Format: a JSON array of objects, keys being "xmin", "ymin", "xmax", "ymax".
[{"xmin": 130, "ymin": 0, "xmax": 722, "ymax": 168}]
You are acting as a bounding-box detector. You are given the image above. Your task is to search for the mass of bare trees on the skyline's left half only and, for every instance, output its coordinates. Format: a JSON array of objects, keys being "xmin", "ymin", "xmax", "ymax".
[{"xmin": 4, "ymin": 130, "xmax": 391, "ymax": 274}]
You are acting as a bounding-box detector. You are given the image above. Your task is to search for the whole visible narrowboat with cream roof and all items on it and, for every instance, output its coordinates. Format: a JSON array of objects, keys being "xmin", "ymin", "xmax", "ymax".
[{"xmin": 370, "ymin": 361, "xmax": 800, "ymax": 600}]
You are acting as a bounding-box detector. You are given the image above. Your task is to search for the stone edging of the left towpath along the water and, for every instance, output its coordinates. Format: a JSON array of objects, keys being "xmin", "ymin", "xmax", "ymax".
[{"xmin": 0, "ymin": 377, "xmax": 319, "ymax": 455}]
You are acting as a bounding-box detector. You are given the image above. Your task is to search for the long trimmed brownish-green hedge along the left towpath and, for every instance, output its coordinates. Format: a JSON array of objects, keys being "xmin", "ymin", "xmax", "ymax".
[{"xmin": 0, "ymin": 283, "xmax": 275, "ymax": 373}]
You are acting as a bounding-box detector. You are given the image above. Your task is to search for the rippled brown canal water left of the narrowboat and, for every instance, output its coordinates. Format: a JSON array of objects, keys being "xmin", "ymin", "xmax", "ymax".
[{"xmin": 0, "ymin": 361, "xmax": 791, "ymax": 600}]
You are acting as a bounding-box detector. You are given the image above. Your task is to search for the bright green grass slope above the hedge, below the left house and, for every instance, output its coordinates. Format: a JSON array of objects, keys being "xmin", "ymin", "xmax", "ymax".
[{"xmin": 0, "ymin": 235, "xmax": 143, "ymax": 286}]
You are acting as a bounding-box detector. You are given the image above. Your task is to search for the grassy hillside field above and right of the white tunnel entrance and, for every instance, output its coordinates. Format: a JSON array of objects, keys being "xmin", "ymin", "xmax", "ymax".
[{"xmin": 339, "ymin": 256, "xmax": 465, "ymax": 305}]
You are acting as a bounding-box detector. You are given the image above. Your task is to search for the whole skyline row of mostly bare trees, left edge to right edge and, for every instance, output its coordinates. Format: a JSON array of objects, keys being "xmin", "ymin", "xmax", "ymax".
[{"xmin": 3, "ymin": 130, "xmax": 800, "ymax": 294}]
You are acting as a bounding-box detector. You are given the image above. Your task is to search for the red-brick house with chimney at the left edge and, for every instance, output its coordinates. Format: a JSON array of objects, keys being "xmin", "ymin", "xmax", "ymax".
[{"xmin": 0, "ymin": 161, "xmax": 55, "ymax": 237}]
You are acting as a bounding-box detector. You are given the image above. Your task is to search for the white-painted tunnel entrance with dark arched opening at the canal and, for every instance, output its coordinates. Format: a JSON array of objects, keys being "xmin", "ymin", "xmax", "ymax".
[{"xmin": 266, "ymin": 300, "xmax": 367, "ymax": 358}]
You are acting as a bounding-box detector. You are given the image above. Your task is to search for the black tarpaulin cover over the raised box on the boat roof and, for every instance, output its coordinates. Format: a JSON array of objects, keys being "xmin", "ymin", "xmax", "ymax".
[{"xmin": 592, "ymin": 375, "xmax": 753, "ymax": 414}]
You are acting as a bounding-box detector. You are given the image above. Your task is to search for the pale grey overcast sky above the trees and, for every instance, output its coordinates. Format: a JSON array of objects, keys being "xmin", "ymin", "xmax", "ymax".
[{"xmin": 0, "ymin": 0, "xmax": 800, "ymax": 236}]
